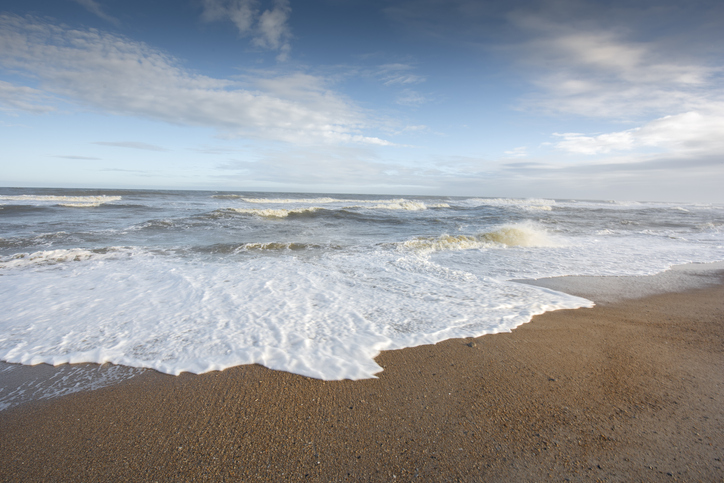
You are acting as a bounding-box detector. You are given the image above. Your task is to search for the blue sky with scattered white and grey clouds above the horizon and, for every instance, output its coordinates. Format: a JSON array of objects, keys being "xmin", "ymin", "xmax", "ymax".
[{"xmin": 0, "ymin": 0, "xmax": 724, "ymax": 203}]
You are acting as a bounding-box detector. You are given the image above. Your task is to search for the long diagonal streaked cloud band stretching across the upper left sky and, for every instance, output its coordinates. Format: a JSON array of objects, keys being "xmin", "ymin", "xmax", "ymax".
[{"xmin": 0, "ymin": 15, "xmax": 389, "ymax": 144}]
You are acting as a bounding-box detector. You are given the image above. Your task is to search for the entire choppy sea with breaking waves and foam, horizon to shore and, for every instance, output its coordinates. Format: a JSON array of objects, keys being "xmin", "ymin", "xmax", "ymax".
[{"xmin": 0, "ymin": 188, "xmax": 724, "ymax": 379}]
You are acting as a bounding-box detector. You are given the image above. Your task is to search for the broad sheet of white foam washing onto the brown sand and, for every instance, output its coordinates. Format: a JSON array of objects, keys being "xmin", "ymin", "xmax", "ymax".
[{"xmin": 0, "ymin": 251, "xmax": 590, "ymax": 379}]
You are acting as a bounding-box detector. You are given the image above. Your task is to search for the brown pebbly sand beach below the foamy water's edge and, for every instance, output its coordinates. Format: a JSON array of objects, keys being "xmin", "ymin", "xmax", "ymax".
[{"xmin": 0, "ymin": 274, "xmax": 724, "ymax": 482}]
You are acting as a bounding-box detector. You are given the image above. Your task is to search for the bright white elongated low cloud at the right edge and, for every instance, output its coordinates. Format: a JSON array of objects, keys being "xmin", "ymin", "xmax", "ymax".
[{"xmin": 555, "ymin": 106, "xmax": 724, "ymax": 156}]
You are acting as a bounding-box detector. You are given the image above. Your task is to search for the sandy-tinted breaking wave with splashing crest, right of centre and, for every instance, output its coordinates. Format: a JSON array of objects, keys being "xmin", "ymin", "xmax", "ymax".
[{"xmin": 400, "ymin": 223, "xmax": 559, "ymax": 252}]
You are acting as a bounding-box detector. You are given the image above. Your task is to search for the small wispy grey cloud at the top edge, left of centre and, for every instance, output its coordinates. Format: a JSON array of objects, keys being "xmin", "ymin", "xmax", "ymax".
[{"xmin": 201, "ymin": 0, "xmax": 292, "ymax": 61}]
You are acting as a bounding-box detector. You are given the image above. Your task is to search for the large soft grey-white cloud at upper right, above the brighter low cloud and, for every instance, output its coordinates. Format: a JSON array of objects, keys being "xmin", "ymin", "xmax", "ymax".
[{"xmin": 507, "ymin": 12, "xmax": 724, "ymax": 120}]
